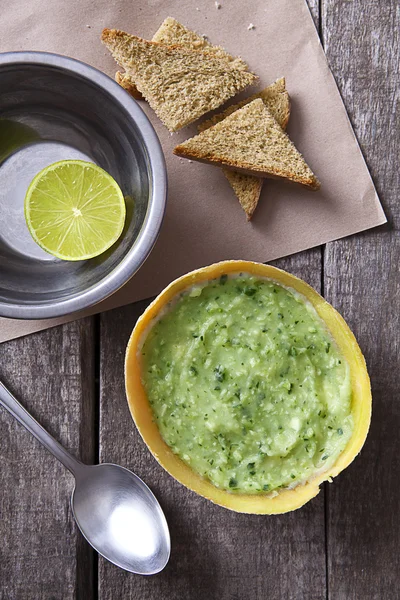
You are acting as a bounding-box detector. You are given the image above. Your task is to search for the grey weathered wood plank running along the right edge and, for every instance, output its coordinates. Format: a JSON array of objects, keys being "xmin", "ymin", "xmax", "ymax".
[{"xmin": 322, "ymin": 0, "xmax": 400, "ymax": 600}]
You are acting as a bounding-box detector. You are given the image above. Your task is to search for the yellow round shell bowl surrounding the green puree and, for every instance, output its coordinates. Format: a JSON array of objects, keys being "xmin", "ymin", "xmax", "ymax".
[{"xmin": 125, "ymin": 261, "xmax": 371, "ymax": 514}]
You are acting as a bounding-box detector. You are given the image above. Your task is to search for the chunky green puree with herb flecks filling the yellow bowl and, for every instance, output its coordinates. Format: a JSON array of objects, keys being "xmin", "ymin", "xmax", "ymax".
[{"xmin": 142, "ymin": 273, "xmax": 353, "ymax": 494}]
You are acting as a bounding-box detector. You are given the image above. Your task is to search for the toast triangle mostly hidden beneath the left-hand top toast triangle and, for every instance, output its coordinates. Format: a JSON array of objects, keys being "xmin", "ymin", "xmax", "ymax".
[{"xmin": 115, "ymin": 17, "xmax": 248, "ymax": 100}]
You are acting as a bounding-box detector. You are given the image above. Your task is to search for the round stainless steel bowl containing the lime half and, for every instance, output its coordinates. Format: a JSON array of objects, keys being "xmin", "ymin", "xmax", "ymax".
[{"xmin": 0, "ymin": 52, "xmax": 167, "ymax": 319}]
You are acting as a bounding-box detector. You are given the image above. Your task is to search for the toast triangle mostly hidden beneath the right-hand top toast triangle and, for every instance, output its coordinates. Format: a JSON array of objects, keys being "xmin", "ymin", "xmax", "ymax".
[{"xmin": 197, "ymin": 77, "xmax": 290, "ymax": 221}]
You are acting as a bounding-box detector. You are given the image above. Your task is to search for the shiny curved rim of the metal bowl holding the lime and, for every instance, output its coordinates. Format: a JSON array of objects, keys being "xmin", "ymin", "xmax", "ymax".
[{"xmin": 0, "ymin": 51, "xmax": 168, "ymax": 319}]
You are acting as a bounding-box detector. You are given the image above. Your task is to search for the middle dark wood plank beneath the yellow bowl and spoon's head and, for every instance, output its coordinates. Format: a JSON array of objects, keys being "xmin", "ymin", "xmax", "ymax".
[{"xmin": 99, "ymin": 250, "xmax": 325, "ymax": 600}]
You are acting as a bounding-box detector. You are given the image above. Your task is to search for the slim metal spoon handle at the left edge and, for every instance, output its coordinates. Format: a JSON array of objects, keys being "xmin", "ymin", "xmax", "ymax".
[{"xmin": 0, "ymin": 381, "xmax": 84, "ymax": 476}]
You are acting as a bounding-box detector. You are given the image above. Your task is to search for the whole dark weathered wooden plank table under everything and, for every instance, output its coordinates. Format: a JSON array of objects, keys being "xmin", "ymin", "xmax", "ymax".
[{"xmin": 0, "ymin": 0, "xmax": 400, "ymax": 600}]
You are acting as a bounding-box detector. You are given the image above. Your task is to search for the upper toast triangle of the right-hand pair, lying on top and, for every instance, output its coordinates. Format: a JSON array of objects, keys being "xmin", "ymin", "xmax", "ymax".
[{"xmin": 174, "ymin": 98, "xmax": 320, "ymax": 190}]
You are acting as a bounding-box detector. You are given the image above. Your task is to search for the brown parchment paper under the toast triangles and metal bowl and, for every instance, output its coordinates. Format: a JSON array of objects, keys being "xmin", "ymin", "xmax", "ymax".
[{"xmin": 0, "ymin": 0, "xmax": 386, "ymax": 342}]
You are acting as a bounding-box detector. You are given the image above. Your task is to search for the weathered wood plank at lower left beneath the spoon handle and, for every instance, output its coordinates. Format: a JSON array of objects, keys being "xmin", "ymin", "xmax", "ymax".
[{"xmin": 0, "ymin": 319, "xmax": 94, "ymax": 600}]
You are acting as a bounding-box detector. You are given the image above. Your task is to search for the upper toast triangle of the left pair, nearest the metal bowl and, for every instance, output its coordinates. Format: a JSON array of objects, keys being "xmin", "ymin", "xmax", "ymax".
[{"xmin": 102, "ymin": 29, "xmax": 257, "ymax": 131}]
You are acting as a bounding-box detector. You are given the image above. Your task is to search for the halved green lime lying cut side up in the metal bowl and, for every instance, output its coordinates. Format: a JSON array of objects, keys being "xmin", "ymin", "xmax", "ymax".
[{"xmin": 25, "ymin": 160, "xmax": 126, "ymax": 260}]
